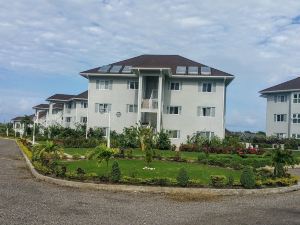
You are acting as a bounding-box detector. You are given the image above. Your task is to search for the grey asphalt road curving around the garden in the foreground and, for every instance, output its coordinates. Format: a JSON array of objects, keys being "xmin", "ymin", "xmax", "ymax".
[{"xmin": 0, "ymin": 139, "xmax": 300, "ymax": 225}]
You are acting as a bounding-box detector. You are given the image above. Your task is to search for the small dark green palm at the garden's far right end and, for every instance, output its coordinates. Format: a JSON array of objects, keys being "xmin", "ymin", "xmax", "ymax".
[{"xmin": 272, "ymin": 149, "xmax": 296, "ymax": 177}]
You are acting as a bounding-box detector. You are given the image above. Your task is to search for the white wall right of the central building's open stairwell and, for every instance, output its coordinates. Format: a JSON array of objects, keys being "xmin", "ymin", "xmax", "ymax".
[{"xmin": 162, "ymin": 79, "xmax": 225, "ymax": 145}]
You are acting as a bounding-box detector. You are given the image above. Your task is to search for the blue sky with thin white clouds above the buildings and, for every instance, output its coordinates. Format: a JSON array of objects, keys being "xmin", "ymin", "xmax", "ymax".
[{"xmin": 0, "ymin": 0, "xmax": 300, "ymax": 131}]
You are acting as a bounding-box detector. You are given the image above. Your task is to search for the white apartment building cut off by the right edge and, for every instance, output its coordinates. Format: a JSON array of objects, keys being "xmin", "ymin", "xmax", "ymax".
[{"xmin": 260, "ymin": 77, "xmax": 300, "ymax": 139}]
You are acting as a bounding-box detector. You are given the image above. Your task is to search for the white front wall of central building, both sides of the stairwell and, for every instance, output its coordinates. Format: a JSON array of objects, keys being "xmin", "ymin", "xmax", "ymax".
[{"xmin": 88, "ymin": 74, "xmax": 226, "ymax": 145}]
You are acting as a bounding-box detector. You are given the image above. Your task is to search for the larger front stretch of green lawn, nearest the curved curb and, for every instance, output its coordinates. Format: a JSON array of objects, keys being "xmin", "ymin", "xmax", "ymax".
[{"xmin": 61, "ymin": 159, "xmax": 241, "ymax": 185}]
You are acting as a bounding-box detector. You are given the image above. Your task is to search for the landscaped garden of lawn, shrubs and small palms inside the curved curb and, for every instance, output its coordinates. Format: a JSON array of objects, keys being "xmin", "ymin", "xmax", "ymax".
[{"xmin": 18, "ymin": 126, "xmax": 299, "ymax": 188}]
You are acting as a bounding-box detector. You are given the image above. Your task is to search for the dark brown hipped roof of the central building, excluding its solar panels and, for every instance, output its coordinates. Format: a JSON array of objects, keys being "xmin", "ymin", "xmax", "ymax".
[{"xmin": 80, "ymin": 55, "xmax": 233, "ymax": 77}]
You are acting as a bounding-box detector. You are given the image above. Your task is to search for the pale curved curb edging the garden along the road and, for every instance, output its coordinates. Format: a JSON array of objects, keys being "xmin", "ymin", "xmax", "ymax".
[{"xmin": 17, "ymin": 140, "xmax": 300, "ymax": 196}]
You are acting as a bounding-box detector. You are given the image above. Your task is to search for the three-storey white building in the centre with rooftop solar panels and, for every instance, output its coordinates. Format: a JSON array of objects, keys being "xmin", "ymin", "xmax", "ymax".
[{"xmin": 80, "ymin": 55, "xmax": 234, "ymax": 145}]
